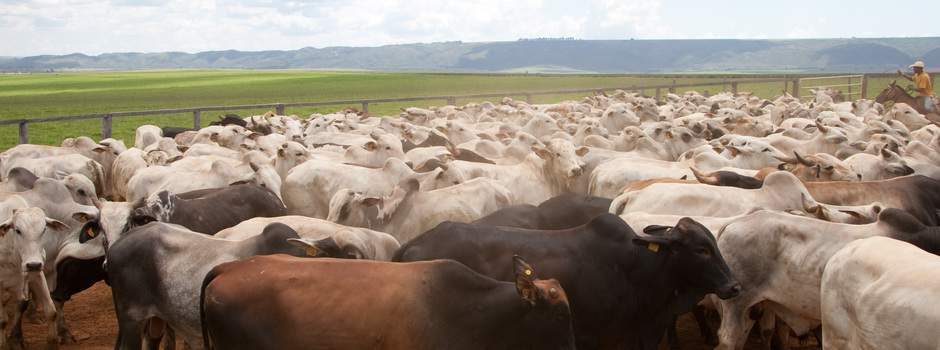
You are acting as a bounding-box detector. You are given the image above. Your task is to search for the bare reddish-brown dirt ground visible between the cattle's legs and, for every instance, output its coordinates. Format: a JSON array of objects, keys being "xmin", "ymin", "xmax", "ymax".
[{"xmin": 14, "ymin": 282, "xmax": 817, "ymax": 350}]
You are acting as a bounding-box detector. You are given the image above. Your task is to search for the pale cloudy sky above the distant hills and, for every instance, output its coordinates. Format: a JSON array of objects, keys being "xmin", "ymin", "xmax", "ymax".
[{"xmin": 0, "ymin": 0, "xmax": 940, "ymax": 57}]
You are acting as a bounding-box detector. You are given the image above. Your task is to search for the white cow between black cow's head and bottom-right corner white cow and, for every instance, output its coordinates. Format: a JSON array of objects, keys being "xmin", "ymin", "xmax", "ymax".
[{"xmin": 717, "ymin": 209, "xmax": 924, "ymax": 349}]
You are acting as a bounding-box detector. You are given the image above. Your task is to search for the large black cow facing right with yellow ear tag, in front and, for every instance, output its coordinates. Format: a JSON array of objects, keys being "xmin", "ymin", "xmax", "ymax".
[{"xmin": 392, "ymin": 213, "xmax": 740, "ymax": 349}]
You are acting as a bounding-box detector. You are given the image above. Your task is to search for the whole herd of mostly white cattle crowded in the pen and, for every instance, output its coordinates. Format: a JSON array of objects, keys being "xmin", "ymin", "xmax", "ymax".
[{"xmin": 0, "ymin": 85, "xmax": 940, "ymax": 349}]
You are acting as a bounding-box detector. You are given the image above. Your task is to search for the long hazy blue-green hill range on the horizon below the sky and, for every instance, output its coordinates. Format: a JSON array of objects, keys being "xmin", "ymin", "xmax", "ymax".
[{"xmin": 0, "ymin": 37, "xmax": 940, "ymax": 74}]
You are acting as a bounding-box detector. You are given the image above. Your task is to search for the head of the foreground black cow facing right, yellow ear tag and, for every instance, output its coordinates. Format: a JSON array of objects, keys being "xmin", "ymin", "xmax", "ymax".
[{"xmin": 633, "ymin": 217, "xmax": 741, "ymax": 302}]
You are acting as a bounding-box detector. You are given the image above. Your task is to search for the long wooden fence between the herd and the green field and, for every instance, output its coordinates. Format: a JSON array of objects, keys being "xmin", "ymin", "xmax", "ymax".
[{"xmin": 0, "ymin": 75, "xmax": 912, "ymax": 144}]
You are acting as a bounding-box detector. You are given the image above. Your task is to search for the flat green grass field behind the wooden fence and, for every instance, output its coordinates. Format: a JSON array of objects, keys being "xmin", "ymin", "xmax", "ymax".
[{"xmin": 0, "ymin": 70, "xmax": 896, "ymax": 150}]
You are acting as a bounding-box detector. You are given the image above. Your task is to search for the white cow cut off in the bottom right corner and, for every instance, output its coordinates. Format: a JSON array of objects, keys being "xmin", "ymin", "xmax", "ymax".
[{"xmin": 820, "ymin": 237, "xmax": 940, "ymax": 349}]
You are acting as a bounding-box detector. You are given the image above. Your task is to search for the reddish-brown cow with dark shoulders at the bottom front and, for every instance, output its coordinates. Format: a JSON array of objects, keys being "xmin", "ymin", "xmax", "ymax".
[{"xmin": 200, "ymin": 255, "xmax": 574, "ymax": 349}]
